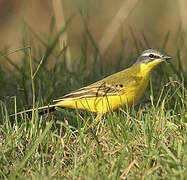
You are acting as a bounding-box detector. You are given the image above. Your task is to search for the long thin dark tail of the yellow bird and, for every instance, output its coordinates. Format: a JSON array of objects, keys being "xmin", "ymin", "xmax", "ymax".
[{"xmin": 9, "ymin": 105, "xmax": 56, "ymax": 117}]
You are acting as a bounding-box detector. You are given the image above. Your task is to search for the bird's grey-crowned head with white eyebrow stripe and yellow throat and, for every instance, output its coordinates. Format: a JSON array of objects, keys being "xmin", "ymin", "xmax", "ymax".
[{"xmin": 136, "ymin": 49, "xmax": 172, "ymax": 70}]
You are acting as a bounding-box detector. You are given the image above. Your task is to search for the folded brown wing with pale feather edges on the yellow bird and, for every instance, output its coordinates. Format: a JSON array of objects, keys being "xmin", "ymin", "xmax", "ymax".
[{"xmin": 54, "ymin": 82, "xmax": 124, "ymax": 102}]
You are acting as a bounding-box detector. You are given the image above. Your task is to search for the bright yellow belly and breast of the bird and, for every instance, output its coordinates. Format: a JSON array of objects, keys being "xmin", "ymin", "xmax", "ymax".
[{"xmin": 56, "ymin": 75, "xmax": 149, "ymax": 114}]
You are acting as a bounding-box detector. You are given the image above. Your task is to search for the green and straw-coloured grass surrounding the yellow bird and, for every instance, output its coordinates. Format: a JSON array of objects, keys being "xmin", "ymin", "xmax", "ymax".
[{"xmin": 0, "ymin": 24, "xmax": 187, "ymax": 179}]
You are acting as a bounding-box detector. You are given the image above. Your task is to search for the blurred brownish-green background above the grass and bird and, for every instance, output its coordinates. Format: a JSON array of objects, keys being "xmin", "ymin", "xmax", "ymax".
[{"xmin": 0, "ymin": 0, "xmax": 187, "ymax": 70}]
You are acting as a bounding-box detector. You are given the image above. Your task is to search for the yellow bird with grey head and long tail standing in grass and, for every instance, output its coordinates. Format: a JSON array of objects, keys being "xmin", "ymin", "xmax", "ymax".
[{"xmin": 11, "ymin": 49, "xmax": 171, "ymax": 116}]
